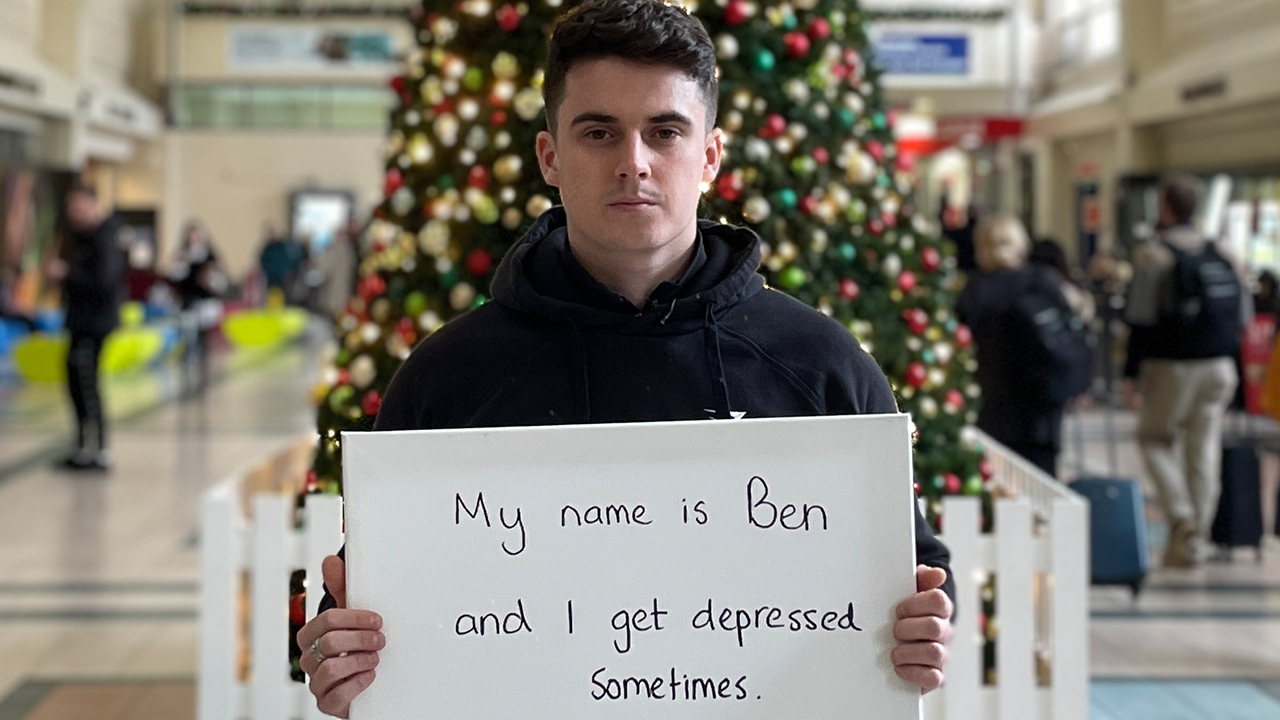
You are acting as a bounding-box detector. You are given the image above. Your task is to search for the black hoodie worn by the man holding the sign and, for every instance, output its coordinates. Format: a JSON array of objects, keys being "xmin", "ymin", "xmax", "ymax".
[{"xmin": 325, "ymin": 209, "xmax": 955, "ymax": 607}]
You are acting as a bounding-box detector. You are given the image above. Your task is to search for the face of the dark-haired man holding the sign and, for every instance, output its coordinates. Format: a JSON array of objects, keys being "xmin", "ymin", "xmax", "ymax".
[{"xmin": 538, "ymin": 58, "xmax": 723, "ymax": 252}]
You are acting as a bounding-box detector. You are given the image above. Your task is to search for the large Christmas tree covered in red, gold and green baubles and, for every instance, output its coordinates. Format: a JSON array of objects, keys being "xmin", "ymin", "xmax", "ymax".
[{"xmin": 307, "ymin": 0, "xmax": 989, "ymax": 516}]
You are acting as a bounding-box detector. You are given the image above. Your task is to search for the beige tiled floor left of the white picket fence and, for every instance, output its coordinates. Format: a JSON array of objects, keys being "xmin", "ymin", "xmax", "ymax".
[{"xmin": 0, "ymin": 333, "xmax": 319, "ymax": 720}]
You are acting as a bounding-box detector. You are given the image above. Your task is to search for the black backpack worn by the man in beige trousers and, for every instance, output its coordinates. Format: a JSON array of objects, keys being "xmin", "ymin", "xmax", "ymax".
[{"xmin": 1161, "ymin": 242, "xmax": 1244, "ymax": 360}]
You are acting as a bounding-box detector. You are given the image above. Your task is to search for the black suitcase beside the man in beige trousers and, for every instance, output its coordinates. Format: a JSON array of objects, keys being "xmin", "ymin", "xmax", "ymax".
[{"xmin": 1210, "ymin": 415, "xmax": 1262, "ymax": 562}]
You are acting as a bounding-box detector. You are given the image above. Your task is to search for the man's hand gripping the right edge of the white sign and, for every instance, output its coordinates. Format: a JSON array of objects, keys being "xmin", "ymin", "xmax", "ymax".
[{"xmin": 890, "ymin": 565, "xmax": 954, "ymax": 693}]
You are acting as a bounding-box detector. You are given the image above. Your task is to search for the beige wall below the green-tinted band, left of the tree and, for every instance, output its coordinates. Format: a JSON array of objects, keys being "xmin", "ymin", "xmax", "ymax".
[{"xmin": 161, "ymin": 131, "xmax": 385, "ymax": 277}]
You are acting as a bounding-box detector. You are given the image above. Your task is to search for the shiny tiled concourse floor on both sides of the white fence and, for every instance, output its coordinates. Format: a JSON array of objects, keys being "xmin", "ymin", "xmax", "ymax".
[{"xmin": 0, "ymin": 347, "xmax": 1280, "ymax": 720}]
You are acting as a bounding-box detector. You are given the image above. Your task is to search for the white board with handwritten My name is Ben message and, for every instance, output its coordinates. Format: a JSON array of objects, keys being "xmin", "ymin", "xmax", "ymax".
[{"xmin": 343, "ymin": 415, "xmax": 920, "ymax": 720}]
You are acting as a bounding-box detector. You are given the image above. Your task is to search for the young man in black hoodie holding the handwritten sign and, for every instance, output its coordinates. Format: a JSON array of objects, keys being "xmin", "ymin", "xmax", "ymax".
[{"xmin": 298, "ymin": 0, "xmax": 952, "ymax": 716}]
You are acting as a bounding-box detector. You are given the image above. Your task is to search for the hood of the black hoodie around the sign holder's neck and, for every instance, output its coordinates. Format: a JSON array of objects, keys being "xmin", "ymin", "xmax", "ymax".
[{"xmin": 493, "ymin": 208, "xmax": 764, "ymax": 334}]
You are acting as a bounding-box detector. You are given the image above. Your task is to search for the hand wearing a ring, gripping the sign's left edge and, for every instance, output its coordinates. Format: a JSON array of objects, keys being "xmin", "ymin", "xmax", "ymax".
[{"xmin": 298, "ymin": 556, "xmax": 387, "ymax": 717}]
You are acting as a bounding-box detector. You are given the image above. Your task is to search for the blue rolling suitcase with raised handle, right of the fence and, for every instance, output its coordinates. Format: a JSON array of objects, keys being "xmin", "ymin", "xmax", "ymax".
[{"xmin": 1070, "ymin": 407, "xmax": 1151, "ymax": 597}]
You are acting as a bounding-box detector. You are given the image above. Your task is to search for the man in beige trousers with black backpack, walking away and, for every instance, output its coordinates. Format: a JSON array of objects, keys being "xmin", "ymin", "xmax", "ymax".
[{"xmin": 1124, "ymin": 177, "xmax": 1253, "ymax": 568}]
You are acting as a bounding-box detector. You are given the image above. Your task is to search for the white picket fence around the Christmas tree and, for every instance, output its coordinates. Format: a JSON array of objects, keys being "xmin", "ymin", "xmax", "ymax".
[{"xmin": 197, "ymin": 433, "xmax": 1089, "ymax": 720}]
